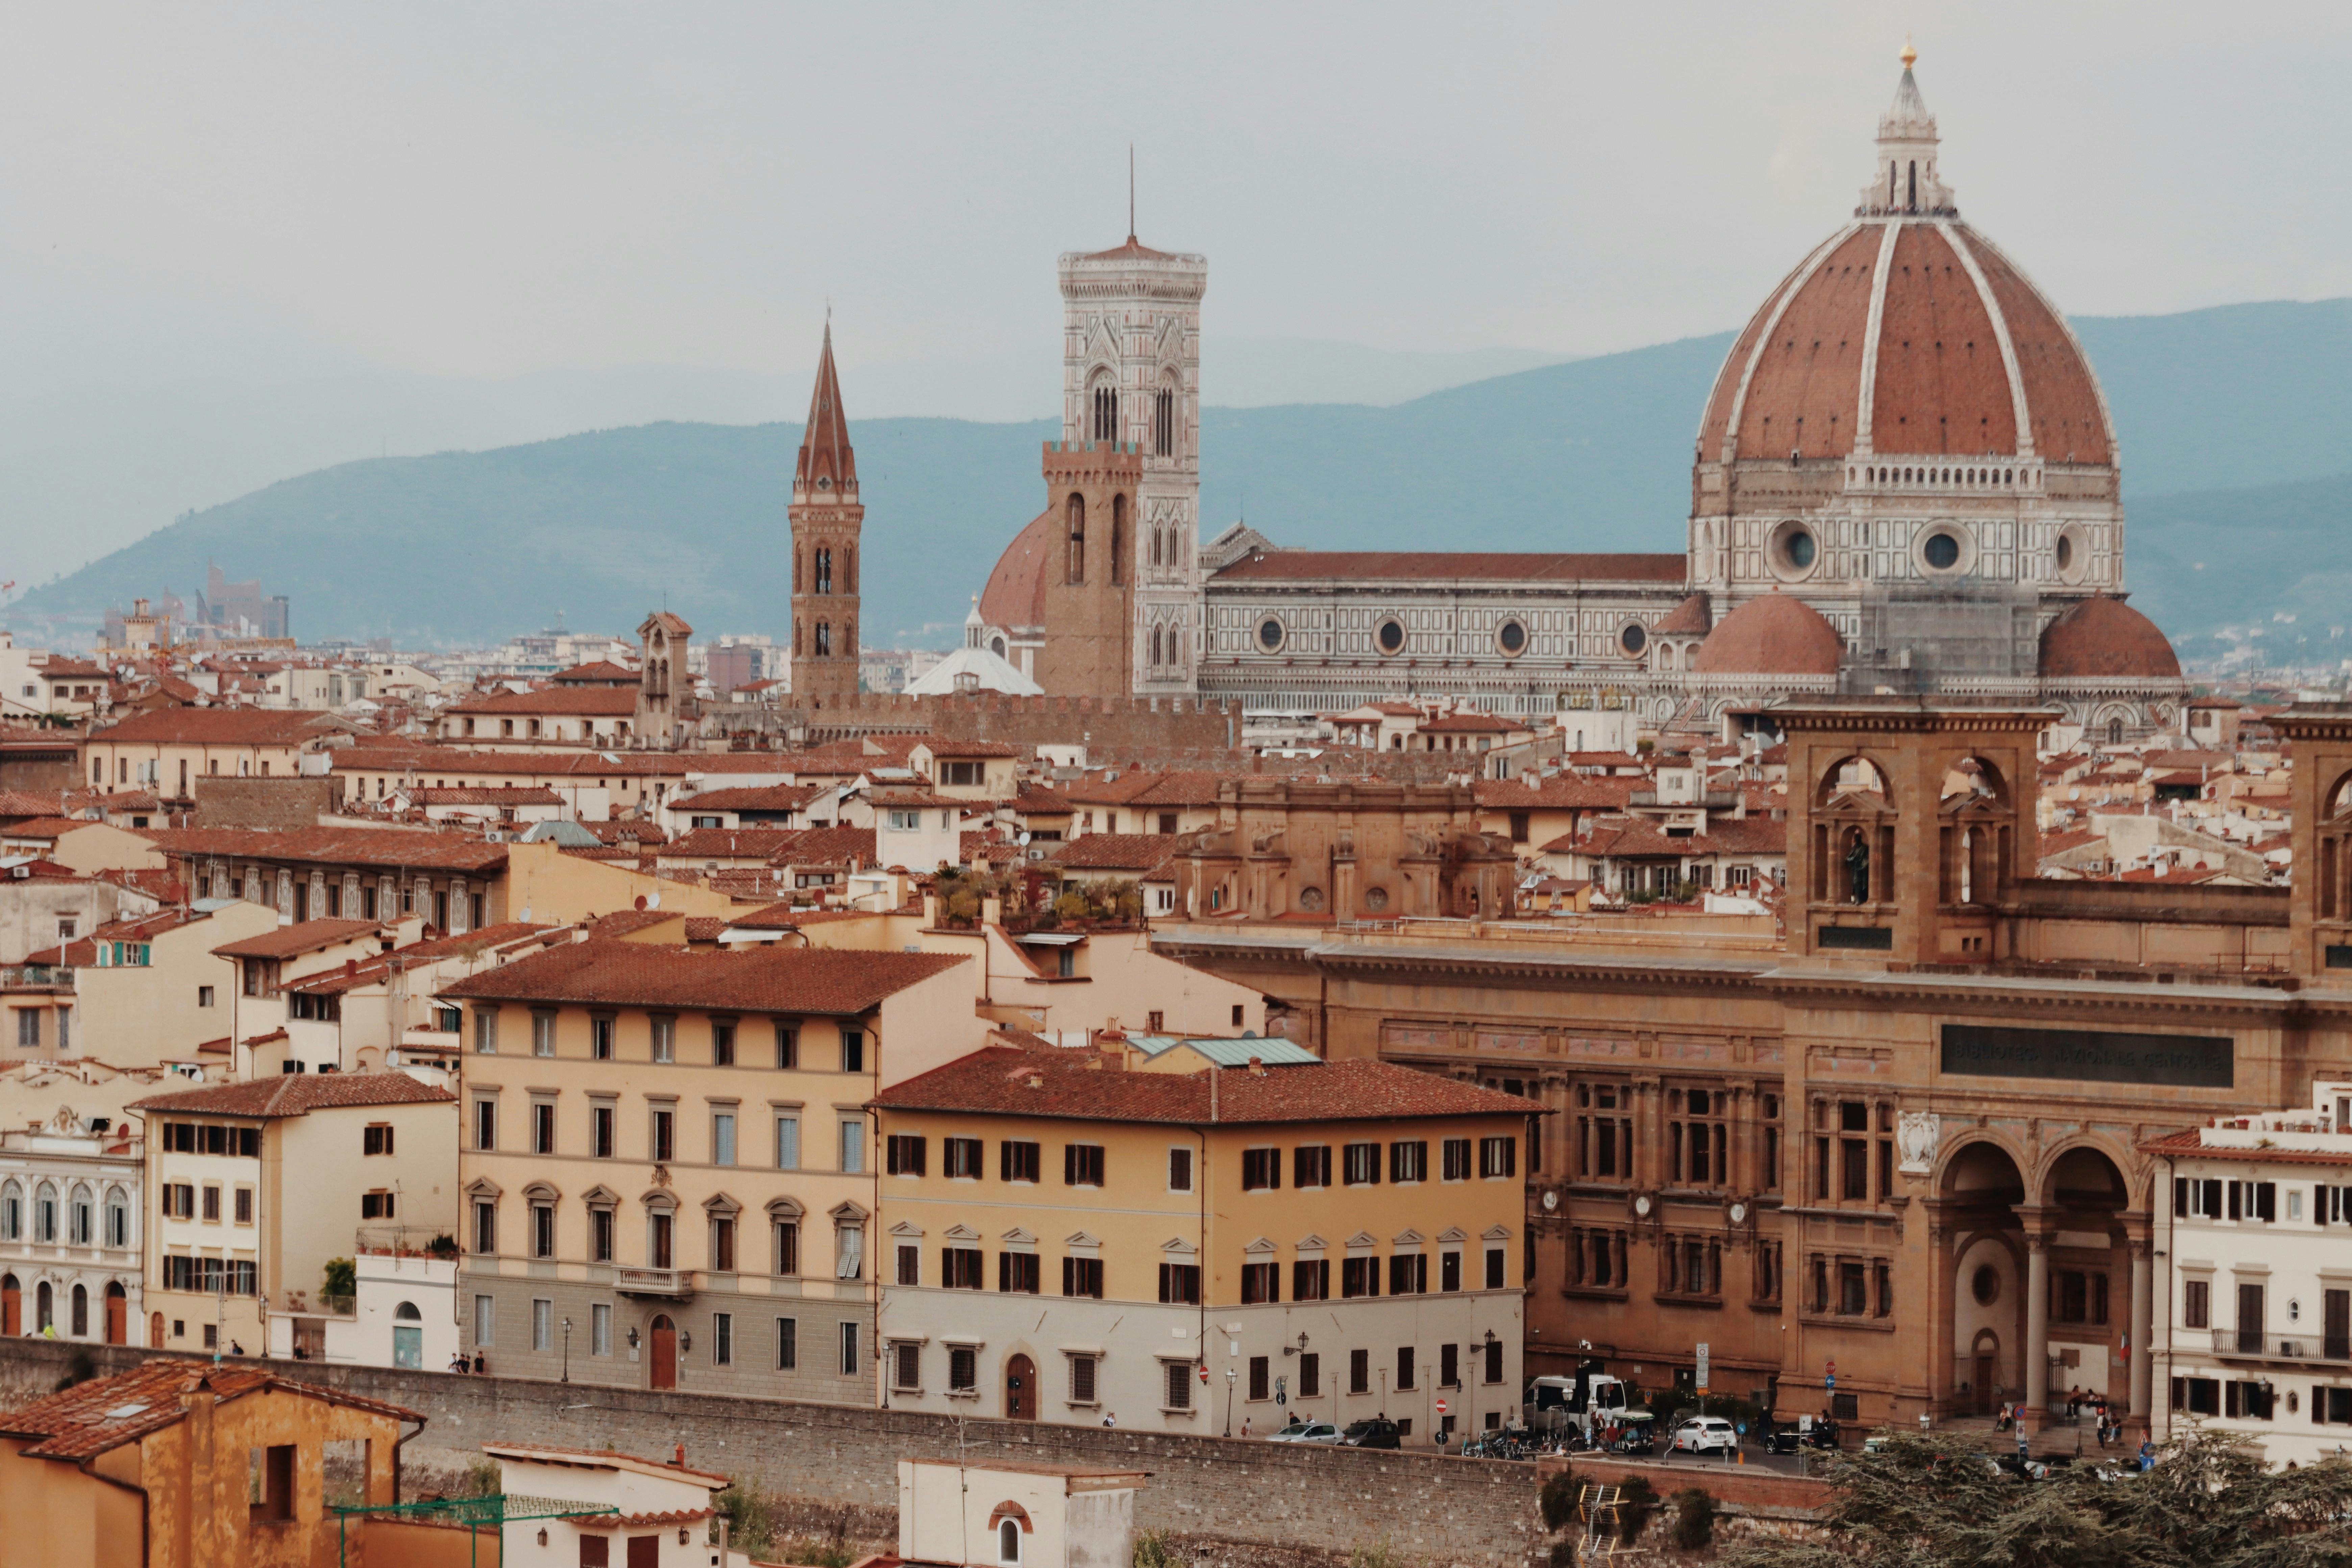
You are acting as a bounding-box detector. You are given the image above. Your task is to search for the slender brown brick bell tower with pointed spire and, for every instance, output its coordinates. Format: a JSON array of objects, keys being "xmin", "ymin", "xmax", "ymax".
[{"xmin": 790, "ymin": 322, "xmax": 865, "ymax": 698}]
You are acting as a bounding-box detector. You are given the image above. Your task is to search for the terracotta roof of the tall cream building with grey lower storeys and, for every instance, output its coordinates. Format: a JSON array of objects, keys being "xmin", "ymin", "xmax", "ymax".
[{"xmin": 440, "ymin": 938, "xmax": 967, "ymax": 1018}]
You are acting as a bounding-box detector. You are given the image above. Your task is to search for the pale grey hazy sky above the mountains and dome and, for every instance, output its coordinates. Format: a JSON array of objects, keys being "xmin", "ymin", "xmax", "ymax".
[{"xmin": 0, "ymin": 0, "xmax": 2352, "ymax": 402}]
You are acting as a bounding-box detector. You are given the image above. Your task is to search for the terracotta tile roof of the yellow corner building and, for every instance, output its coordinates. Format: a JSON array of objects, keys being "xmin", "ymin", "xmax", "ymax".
[{"xmin": 873, "ymin": 1046, "xmax": 1543, "ymax": 1124}]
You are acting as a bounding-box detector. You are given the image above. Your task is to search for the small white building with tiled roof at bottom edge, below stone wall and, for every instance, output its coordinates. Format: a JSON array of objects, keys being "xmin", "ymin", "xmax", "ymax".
[{"xmin": 482, "ymin": 1443, "xmax": 729, "ymax": 1568}]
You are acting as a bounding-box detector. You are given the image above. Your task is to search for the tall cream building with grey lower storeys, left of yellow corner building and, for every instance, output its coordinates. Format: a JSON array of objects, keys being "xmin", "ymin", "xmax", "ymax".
[{"xmin": 442, "ymin": 938, "xmax": 983, "ymax": 1406}]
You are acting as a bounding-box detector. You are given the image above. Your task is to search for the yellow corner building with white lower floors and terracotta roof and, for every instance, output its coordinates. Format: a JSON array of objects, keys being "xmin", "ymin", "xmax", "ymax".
[{"xmin": 875, "ymin": 1046, "xmax": 1541, "ymax": 1443}]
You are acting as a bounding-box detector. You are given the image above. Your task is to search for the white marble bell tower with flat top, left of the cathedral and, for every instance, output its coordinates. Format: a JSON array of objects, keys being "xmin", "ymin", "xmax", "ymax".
[{"xmin": 1068, "ymin": 233, "xmax": 1209, "ymax": 696}]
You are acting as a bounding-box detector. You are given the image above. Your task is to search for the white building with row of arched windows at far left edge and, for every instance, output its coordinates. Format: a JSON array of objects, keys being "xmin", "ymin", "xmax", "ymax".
[{"xmin": 0, "ymin": 1107, "xmax": 144, "ymax": 1345}]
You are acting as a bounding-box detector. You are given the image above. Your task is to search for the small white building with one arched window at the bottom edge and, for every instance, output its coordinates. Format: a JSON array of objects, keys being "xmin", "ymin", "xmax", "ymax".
[{"xmin": 899, "ymin": 1460, "xmax": 1148, "ymax": 1568}]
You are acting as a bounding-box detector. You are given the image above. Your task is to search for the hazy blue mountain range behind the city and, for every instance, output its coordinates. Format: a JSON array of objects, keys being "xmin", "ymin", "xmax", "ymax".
[{"xmin": 14, "ymin": 301, "xmax": 2352, "ymax": 663}]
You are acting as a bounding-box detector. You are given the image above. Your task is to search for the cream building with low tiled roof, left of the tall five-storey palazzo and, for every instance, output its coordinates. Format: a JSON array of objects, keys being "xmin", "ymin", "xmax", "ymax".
[{"xmin": 129, "ymin": 1072, "xmax": 459, "ymax": 1354}]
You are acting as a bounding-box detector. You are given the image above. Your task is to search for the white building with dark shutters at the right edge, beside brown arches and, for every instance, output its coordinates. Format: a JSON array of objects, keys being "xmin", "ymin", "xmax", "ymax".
[{"xmin": 2140, "ymin": 1081, "xmax": 2352, "ymax": 1465}]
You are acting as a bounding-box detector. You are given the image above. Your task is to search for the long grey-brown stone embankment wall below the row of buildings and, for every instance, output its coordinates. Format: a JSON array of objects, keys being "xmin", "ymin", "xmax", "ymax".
[{"xmin": 0, "ymin": 1340, "xmax": 1543, "ymax": 1568}]
